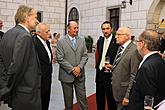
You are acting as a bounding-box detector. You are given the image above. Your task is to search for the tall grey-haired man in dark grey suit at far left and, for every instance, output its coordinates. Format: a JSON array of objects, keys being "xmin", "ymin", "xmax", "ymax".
[{"xmin": 0, "ymin": 5, "xmax": 41, "ymax": 110}]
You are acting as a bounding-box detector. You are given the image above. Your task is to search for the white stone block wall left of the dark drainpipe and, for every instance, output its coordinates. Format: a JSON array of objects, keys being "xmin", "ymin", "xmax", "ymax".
[{"xmin": 0, "ymin": 0, "xmax": 65, "ymax": 34}]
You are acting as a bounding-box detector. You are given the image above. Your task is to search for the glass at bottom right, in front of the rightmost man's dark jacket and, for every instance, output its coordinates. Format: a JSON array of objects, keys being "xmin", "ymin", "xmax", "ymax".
[{"xmin": 144, "ymin": 95, "xmax": 154, "ymax": 110}]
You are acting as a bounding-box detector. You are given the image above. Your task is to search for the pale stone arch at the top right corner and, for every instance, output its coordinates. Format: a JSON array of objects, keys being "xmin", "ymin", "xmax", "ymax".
[{"xmin": 146, "ymin": 0, "xmax": 165, "ymax": 29}]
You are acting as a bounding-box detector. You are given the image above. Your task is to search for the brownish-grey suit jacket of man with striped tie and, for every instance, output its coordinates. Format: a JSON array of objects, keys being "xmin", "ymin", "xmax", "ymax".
[{"xmin": 112, "ymin": 41, "xmax": 141, "ymax": 102}]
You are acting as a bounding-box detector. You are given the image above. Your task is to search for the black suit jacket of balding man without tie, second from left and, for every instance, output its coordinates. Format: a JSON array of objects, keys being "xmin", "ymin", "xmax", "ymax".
[{"xmin": 33, "ymin": 35, "xmax": 52, "ymax": 91}]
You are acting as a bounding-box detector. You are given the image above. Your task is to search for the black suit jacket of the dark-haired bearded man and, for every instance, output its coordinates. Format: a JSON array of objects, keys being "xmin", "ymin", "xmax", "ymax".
[{"xmin": 95, "ymin": 35, "xmax": 119, "ymax": 82}]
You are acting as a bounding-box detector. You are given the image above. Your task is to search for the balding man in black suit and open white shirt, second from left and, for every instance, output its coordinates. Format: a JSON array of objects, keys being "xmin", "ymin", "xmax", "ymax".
[{"xmin": 33, "ymin": 23, "xmax": 52, "ymax": 110}]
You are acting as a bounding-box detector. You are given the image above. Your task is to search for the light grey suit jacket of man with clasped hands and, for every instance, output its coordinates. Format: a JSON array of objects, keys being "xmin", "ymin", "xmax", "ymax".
[{"xmin": 56, "ymin": 35, "xmax": 88, "ymax": 83}]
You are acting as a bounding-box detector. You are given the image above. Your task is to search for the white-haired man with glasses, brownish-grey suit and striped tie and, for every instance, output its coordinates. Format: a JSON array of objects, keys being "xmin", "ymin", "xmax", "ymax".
[{"xmin": 105, "ymin": 27, "xmax": 141, "ymax": 110}]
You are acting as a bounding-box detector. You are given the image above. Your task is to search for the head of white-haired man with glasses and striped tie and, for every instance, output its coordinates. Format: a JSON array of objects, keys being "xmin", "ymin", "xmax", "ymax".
[{"xmin": 116, "ymin": 27, "xmax": 131, "ymax": 45}]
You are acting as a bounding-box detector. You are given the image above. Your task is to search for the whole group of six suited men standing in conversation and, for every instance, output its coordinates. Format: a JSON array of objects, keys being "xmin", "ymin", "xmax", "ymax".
[{"xmin": 0, "ymin": 5, "xmax": 165, "ymax": 110}]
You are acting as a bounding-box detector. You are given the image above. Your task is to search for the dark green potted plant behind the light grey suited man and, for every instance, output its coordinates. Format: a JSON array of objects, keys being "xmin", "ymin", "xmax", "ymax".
[{"xmin": 85, "ymin": 35, "xmax": 93, "ymax": 53}]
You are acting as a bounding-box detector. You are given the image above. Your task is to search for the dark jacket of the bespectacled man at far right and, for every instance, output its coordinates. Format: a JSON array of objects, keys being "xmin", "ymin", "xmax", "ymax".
[{"xmin": 128, "ymin": 53, "xmax": 165, "ymax": 110}]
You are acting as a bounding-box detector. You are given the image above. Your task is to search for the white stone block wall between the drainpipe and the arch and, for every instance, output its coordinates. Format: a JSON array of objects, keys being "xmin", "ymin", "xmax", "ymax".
[{"xmin": 68, "ymin": 0, "xmax": 156, "ymax": 42}]
